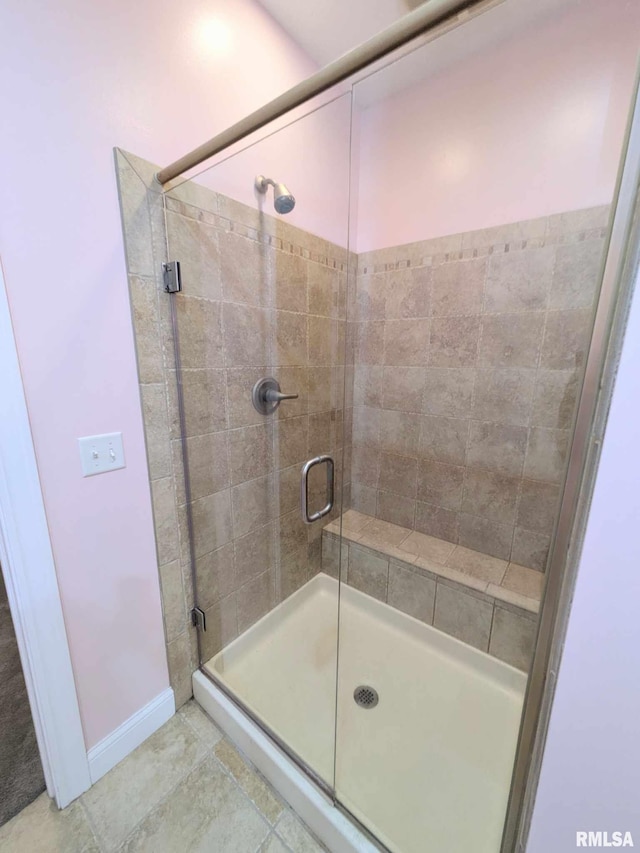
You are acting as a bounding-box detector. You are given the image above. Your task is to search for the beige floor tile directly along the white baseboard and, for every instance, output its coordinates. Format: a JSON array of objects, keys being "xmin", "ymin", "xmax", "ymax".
[{"xmin": 82, "ymin": 714, "xmax": 206, "ymax": 851}]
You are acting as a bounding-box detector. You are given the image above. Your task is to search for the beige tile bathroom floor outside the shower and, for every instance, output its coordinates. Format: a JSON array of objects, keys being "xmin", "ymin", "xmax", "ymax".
[{"xmin": 0, "ymin": 700, "xmax": 326, "ymax": 853}]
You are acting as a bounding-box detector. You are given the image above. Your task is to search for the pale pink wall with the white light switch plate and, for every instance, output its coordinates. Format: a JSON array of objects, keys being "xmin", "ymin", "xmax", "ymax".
[{"xmin": 0, "ymin": 0, "xmax": 314, "ymax": 747}]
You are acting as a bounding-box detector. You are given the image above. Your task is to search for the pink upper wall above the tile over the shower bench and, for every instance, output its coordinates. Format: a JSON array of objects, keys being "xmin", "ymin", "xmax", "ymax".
[{"xmin": 355, "ymin": 0, "xmax": 640, "ymax": 252}]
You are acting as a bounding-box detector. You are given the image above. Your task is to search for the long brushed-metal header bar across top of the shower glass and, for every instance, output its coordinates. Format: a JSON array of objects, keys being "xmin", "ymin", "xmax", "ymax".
[{"xmin": 156, "ymin": 0, "xmax": 490, "ymax": 186}]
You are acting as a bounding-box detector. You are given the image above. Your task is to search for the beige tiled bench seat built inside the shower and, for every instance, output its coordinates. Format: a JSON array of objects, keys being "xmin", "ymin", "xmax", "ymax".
[{"xmin": 322, "ymin": 510, "xmax": 544, "ymax": 671}]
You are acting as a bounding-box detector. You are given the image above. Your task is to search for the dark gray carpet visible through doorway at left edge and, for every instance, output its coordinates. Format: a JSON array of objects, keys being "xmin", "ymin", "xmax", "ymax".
[{"xmin": 0, "ymin": 571, "xmax": 45, "ymax": 826}]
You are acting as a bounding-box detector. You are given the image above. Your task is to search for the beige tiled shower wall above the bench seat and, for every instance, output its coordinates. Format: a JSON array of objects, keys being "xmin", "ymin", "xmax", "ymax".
[{"xmin": 351, "ymin": 206, "xmax": 609, "ymax": 570}]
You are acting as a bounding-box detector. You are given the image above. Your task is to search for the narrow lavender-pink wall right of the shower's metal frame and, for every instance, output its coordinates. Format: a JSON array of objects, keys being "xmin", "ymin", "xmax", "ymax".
[{"xmin": 527, "ymin": 264, "xmax": 640, "ymax": 853}]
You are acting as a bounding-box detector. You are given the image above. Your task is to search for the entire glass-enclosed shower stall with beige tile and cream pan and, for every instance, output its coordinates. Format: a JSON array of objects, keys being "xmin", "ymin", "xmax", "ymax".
[{"xmin": 116, "ymin": 0, "xmax": 640, "ymax": 853}]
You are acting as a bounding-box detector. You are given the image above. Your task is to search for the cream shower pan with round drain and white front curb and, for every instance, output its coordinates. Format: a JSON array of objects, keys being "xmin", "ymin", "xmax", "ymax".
[{"xmin": 194, "ymin": 574, "xmax": 526, "ymax": 853}]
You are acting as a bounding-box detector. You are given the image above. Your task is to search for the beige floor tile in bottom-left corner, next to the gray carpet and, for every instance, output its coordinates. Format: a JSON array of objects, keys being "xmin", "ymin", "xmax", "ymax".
[{"xmin": 0, "ymin": 793, "xmax": 98, "ymax": 853}]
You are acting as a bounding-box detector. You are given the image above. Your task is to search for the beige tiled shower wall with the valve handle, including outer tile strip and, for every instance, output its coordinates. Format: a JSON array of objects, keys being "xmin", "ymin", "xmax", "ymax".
[{"xmin": 117, "ymin": 152, "xmax": 355, "ymax": 704}]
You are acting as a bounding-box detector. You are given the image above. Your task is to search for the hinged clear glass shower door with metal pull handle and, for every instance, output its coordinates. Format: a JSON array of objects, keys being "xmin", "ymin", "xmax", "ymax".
[{"xmin": 165, "ymin": 93, "xmax": 351, "ymax": 787}]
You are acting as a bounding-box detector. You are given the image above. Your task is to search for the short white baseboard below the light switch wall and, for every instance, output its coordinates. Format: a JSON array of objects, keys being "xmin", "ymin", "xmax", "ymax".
[{"xmin": 87, "ymin": 687, "xmax": 176, "ymax": 784}]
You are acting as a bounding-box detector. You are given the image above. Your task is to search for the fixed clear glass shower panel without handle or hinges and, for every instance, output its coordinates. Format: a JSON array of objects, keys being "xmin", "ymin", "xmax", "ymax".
[{"xmin": 336, "ymin": 0, "xmax": 640, "ymax": 853}]
